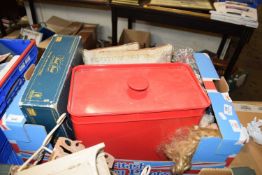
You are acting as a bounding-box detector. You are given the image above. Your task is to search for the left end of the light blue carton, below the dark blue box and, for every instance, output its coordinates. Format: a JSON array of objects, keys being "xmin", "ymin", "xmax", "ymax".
[{"xmin": 0, "ymin": 81, "xmax": 51, "ymax": 163}]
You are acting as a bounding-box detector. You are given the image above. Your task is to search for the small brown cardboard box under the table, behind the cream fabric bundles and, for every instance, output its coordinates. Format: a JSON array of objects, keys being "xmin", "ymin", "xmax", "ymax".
[{"xmin": 119, "ymin": 29, "xmax": 151, "ymax": 48}]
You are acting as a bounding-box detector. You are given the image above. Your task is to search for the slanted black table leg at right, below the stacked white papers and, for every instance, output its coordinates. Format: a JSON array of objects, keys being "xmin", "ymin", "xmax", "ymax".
[{"xmin": 225, "ymin": 29, "xmax": 252, "ymax": 79}]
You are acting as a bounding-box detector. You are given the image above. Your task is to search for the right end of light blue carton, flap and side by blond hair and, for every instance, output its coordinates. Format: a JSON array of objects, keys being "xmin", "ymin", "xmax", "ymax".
[{"xmin": 193, "ymin": 53, "xmax": 246, "ymax": 163}]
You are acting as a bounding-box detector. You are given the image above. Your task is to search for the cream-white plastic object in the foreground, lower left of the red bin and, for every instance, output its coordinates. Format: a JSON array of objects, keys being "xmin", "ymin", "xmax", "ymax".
[{"xmin": 17, "ymin": 143, "xmax": 110, "ymax": 175}]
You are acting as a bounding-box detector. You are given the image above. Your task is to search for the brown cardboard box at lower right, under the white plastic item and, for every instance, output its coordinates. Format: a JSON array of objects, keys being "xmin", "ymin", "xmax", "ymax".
[{"xmin": 230, "ymin": 102, "xmax": 262, "ymax": 175}]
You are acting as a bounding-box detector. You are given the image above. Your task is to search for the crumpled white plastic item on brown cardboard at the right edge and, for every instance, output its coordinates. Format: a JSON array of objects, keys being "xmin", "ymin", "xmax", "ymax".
[{"xmin": 247, "ymin": 117, "xmax": 262, "ymax": 145}]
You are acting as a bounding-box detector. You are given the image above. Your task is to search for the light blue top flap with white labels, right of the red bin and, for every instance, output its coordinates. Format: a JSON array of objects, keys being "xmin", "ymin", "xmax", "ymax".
[{"xmin": 194, "ymin": 53, "xmax": 241, "ymax": 142}]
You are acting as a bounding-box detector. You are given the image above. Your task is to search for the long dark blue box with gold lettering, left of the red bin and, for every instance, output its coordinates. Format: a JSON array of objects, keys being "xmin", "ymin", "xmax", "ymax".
[{"xmin": 19, "ymin": 35, "xmax": 82, "ymax": 138}]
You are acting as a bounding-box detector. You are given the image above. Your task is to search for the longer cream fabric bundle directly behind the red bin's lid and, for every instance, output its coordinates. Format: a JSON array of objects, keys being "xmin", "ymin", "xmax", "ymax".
[{"xmin": 84, "ymin": 44, "xmax": 173, "ymax": 64}]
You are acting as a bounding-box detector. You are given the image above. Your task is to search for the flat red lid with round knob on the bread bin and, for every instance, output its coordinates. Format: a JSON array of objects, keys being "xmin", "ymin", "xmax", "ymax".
[{"xmin": 68, "ymin": 63, "xmax": 210, "ymax": 116}]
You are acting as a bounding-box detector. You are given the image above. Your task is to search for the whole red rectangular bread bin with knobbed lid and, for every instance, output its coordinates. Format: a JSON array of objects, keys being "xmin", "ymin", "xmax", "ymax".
[{"xmin": 67, "ymin": 63, "xmax": 210, "ymax": 160}]
